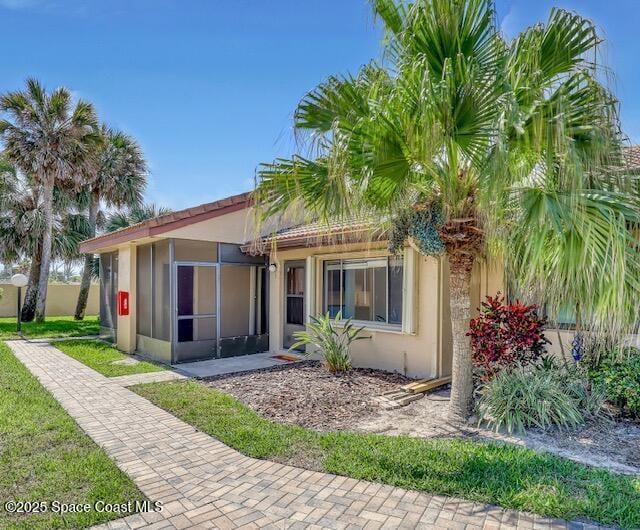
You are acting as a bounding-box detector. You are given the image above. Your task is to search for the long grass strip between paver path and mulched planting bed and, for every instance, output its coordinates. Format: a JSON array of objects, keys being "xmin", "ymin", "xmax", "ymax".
[{"xmin": 134, "ymin": 381, "xmax": 640, "ymax": 528}]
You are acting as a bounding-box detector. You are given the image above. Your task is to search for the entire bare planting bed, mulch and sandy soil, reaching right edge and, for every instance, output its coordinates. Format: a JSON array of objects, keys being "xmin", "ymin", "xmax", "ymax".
[{"xmin": 203, "ymin": 361, "xmax": 640, "ymax": 475}]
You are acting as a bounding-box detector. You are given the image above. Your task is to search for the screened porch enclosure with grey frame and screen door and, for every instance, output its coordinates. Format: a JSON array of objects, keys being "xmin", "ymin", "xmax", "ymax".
[{"xmin": 136, "ymin": 239, "xmax": 269, "ymax": 363}]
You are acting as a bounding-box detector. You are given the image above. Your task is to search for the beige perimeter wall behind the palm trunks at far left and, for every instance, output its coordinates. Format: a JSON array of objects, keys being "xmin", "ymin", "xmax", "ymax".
[{"xmin": 0, "ymin": 283, "xmax": 100, "ymax": 317}]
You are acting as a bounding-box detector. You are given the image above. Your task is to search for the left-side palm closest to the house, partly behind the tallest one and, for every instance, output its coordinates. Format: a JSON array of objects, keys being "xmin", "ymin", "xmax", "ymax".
[{"xmin": 74, "ymin": 125, "xmax": 147, "ymax": 320}]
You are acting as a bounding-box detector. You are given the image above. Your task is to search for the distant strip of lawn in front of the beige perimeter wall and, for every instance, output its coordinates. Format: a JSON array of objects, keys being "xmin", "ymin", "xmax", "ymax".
[{"xmin": 0, "ymin": 316, "xmax": 100, "ymax": 340}]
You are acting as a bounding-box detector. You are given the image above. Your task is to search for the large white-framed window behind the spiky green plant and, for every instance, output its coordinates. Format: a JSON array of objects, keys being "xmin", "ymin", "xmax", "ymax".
[{"xmin": 324, "ymin": 256, "xmax": 404, "ymax": 326}]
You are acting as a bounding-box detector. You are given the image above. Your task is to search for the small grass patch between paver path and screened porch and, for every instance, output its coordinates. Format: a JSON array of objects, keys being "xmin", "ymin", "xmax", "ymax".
[{"xmin": 54, "ymin": 340, "xmax": 165, "ymax": 377}]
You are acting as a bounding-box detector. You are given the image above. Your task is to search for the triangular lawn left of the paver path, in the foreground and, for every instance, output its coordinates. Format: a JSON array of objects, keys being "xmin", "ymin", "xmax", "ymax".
[{"xmin": 0, "ymin": 343, "xmax": 145, "ymax": 530}]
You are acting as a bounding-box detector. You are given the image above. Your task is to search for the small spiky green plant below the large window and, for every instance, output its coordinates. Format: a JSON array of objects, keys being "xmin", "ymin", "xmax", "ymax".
[{"xmin": 290, "ymin": 312, "xmax": 366, "ymax": 373}]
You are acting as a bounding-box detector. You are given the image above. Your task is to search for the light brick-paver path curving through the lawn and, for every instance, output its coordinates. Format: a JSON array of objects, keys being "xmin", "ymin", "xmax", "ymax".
[{"xmin": 8, "ymin": 341, "xmax": 596, "ymax": 530}]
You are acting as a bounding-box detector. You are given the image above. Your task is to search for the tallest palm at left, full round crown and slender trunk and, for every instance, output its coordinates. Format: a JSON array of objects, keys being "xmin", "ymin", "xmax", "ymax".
[{"xmin": 0, "ymin": 79, "xmax": 100, "ymax": 322}]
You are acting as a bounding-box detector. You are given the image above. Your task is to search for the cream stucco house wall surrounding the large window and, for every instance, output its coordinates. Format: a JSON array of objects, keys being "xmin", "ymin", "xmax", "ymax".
[{"xmin": 269, "ymin": 243, "xmax": 504, "ymax": 377}]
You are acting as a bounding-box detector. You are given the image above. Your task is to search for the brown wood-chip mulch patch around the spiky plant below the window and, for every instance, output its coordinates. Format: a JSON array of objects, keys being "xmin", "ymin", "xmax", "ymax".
[{"xmin": 203, "ymin": 361, "xmax": 411, "ymax": 430}]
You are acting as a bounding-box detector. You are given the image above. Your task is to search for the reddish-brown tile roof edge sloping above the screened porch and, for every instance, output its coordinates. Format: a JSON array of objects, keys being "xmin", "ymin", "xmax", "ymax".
[{"xmin": 80, "ymin": 192, "xmax": 251, "ymax": 253}]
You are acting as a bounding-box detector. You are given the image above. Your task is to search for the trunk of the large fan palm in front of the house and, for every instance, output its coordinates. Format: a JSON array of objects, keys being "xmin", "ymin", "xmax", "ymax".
[{"xmin": 448, "ymin": 255, "xmax": 473, "ymax": 421}]
